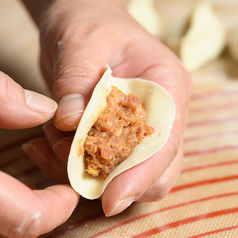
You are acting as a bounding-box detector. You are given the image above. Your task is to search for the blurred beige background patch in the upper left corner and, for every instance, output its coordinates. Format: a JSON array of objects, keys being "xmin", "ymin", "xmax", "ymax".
[{"xmin": 0, "ymin": 0, "xmax": 48, "ymax": 93}]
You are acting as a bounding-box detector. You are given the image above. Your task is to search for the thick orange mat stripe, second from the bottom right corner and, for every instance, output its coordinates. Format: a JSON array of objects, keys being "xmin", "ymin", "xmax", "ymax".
[{"xmin": 132, "ymin": 207, "xmax": 238, "ymax": 238}]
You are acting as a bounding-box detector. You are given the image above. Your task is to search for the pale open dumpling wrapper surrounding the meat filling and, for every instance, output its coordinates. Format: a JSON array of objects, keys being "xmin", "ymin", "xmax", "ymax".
[{"xmin": 68, "ymin": 67, "xmax": 175, "ymax": 199}]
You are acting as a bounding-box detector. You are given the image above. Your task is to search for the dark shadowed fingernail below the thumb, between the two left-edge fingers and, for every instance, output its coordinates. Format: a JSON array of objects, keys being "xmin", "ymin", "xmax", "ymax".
[{"xmin": 22, "ymin": 143, "xmax": 49, "ymax": 168}]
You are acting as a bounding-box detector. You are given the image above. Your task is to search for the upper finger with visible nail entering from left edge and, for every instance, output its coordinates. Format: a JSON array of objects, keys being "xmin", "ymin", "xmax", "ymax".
[{"xmin": 0, "ymin": 72, "xmax": 57, "ymax": 129}]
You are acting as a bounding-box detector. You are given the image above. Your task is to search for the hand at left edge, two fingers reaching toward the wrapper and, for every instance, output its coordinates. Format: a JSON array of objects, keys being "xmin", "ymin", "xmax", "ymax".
[{"xmin": 0, "ymin": 72, "xmax": 78, "ymax": 238}]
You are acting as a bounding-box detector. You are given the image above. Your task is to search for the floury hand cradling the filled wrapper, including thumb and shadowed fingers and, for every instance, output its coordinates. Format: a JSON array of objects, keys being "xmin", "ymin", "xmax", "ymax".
[{"xmin": 21, "ymin": 0, "xmax": 192, "ymax": 221}]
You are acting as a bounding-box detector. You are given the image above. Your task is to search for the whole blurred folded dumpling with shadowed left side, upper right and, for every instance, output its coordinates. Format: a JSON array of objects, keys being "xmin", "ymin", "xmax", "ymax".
[{"xmin": 164, "ymin": 0, "xmax": 227, "ymax": 72}]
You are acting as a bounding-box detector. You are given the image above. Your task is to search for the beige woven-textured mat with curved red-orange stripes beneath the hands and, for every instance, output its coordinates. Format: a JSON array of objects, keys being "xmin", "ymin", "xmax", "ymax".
[{"xmin": 0, "ymin": 0, "xmax": 238, "ymax": 238}]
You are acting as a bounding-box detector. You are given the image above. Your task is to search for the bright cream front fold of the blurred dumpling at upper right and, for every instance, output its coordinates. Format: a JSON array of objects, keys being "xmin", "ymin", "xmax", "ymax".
[{"xmin": 179, "ymin": 1, "xmax": 227, "ymax": 72}]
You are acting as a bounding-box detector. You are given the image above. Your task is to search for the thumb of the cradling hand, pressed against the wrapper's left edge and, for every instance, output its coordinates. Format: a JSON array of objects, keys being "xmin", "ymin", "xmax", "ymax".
[{"xmin": 53, "ymin": 37, "xmax": 109, "ymax": 131}]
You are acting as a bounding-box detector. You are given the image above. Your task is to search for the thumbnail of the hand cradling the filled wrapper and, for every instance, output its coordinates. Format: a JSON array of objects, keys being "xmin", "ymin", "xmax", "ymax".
[{"xmin": 55, "ymin": 94, "xmax": 85, "ymax": 121}]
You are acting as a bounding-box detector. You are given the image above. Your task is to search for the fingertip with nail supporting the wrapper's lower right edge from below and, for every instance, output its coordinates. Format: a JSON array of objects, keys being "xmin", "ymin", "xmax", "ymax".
[{"xmin": 102, "ymin": 152, "xmax": 167, "ymax": 216}]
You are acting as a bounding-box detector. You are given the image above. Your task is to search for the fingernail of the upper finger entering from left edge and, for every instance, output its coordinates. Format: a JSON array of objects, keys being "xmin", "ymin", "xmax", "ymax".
[{"xmin": 25, "ymin": 89, "xmax": 57, "ymax": 115}]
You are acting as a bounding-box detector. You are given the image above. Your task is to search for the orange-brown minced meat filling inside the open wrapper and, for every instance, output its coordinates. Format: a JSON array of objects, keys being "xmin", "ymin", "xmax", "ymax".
[{"xmin": 84, "ymin": 86, "xmax": 154, "ymax": 177}]
